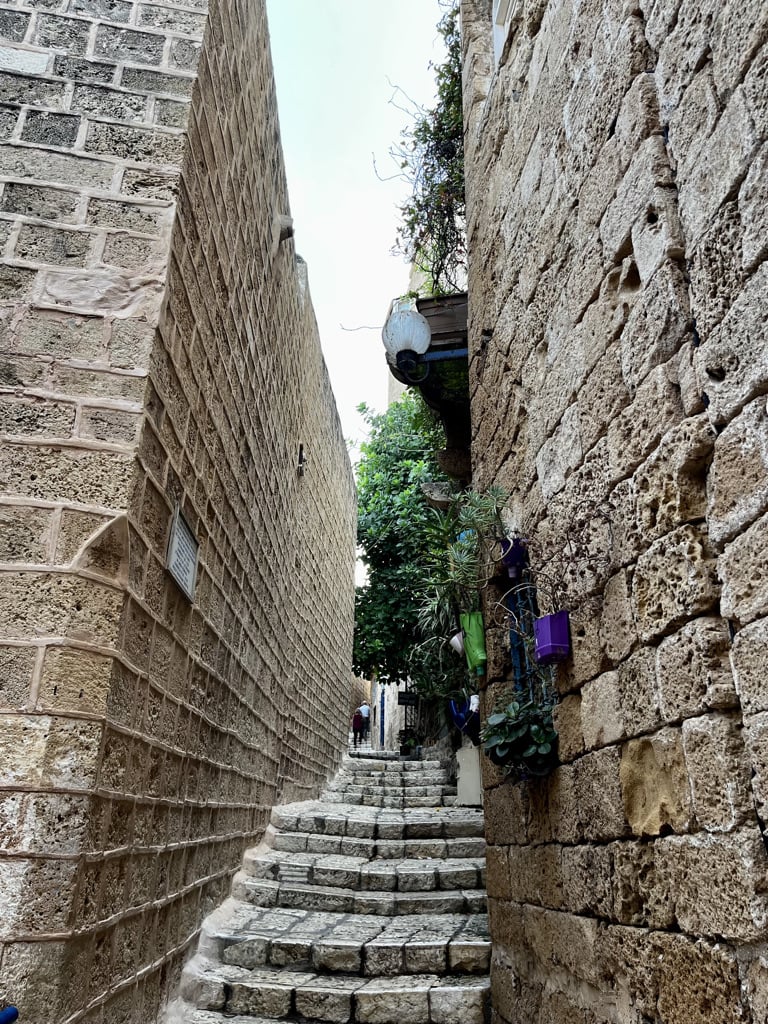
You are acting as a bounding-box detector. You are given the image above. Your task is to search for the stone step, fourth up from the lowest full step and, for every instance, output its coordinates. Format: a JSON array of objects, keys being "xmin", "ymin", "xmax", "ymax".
[{"xmin": 243, "ymin": 847, "xmax": 485, "ymax": 892}]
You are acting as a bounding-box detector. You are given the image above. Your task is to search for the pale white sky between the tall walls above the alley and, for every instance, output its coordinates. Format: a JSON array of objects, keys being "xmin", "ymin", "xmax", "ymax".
[{"xmin": 266, "ymin": 0, "xmax": 443, "ymax": 452}]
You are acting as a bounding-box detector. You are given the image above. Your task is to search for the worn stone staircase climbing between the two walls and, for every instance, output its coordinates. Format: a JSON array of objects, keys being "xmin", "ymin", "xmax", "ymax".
[{"xmin": 167, "ymin": 752, "xmax": 490, "ymax": 1024}]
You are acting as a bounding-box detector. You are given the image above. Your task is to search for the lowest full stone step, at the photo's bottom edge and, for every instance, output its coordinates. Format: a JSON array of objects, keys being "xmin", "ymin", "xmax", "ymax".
[{"xmin": 178, "ymin": 954, "xmax": 489, "ymax": 1024}]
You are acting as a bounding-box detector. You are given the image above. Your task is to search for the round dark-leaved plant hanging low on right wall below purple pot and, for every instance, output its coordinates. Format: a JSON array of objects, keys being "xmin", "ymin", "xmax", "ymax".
[{"xmin": 481, "ymin": 695, "xmax": 557, "ymax": 775}]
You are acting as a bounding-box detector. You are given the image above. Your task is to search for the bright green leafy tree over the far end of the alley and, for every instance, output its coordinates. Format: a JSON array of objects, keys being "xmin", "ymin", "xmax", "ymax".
[{"xmin": 353, "ymin": 394, "xmax": 450, "ymax": 691}]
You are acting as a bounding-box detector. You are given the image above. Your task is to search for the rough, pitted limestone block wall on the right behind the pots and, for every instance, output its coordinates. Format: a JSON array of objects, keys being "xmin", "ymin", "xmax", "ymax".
[{"xmin": 462, "ymin": 0, "xmax": 768, "ymax": 1024}]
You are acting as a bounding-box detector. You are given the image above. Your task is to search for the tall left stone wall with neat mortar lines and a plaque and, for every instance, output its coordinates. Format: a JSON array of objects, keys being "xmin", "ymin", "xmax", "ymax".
[{"xmin": 0, "ymin": 0, "xmax": 354, "ymax": 1024}]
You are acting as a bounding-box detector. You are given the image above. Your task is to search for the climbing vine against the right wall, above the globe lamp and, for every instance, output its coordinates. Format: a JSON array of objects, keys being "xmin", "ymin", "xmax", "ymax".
[{"xmin": 392, "ymin": 0, "xmax": 466, "ymax": 295}]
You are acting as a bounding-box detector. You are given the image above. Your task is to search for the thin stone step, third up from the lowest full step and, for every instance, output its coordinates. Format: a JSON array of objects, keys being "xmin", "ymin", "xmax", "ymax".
[{"xmin": 232, "ymin": 871, "xmax": 485, "ymax": 918}]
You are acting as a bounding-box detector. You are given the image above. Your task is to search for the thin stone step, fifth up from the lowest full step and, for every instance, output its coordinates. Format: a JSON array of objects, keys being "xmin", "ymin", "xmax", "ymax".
[{"xmin": 265, "ymin": 830, "xmax": 485, "ymax": 860}]
